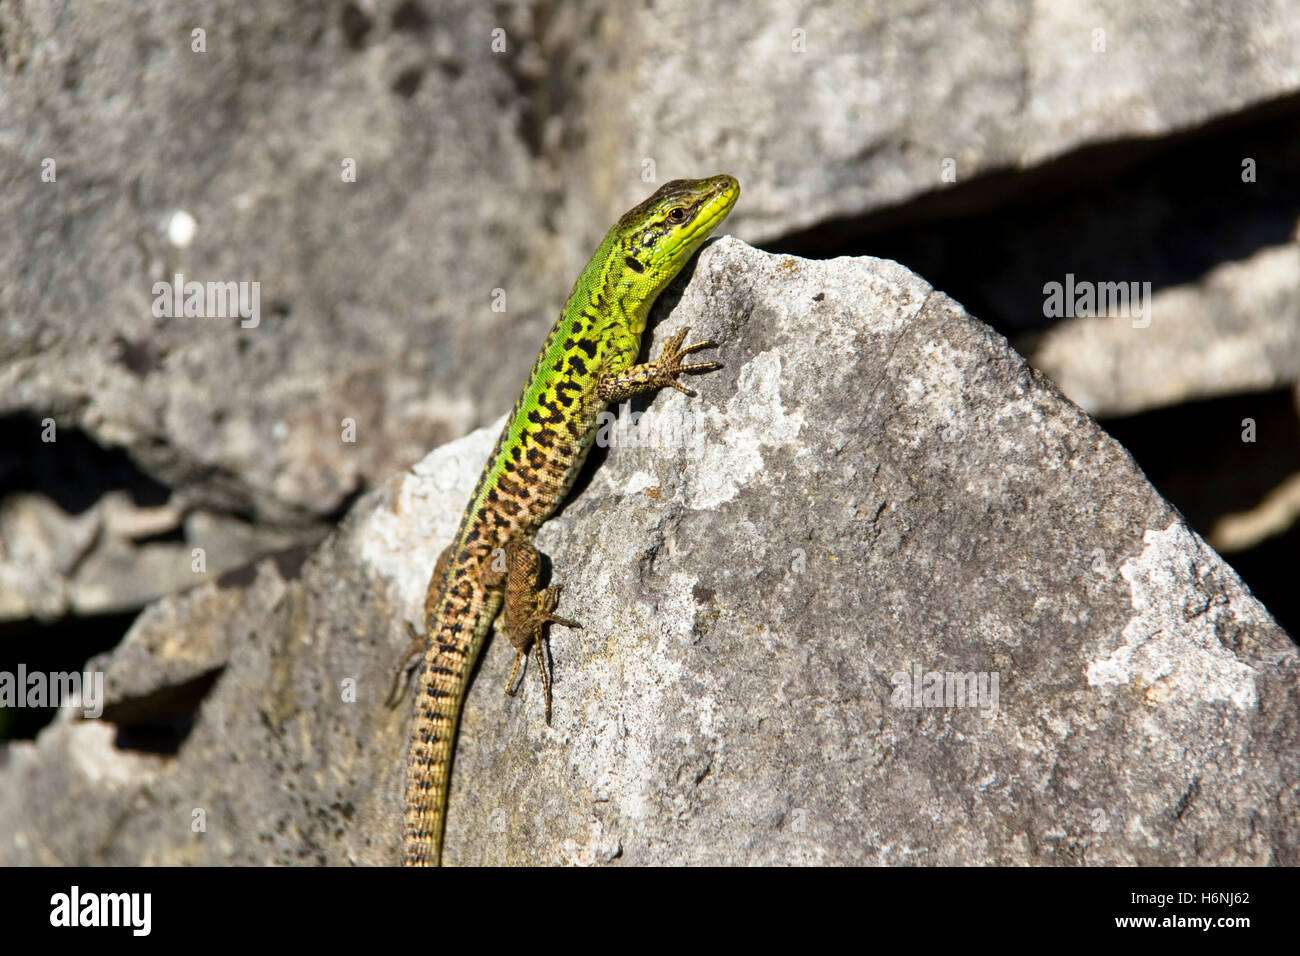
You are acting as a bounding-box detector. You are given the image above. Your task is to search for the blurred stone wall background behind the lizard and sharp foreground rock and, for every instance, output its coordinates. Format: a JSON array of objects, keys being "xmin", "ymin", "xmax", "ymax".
[{"xmin": 0, "ymin": 0, "xmax": 1300, "ymax": 863}]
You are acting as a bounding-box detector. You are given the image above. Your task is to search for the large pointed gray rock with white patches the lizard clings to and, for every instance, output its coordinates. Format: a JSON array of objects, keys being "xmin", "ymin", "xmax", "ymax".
[{"xmin": 0, "ymin": 239, "xmax": 1300, "ymax": 864}]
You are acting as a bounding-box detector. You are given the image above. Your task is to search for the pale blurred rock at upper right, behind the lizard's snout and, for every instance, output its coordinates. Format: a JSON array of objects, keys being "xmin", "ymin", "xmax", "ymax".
[{"xmin": 556, "ymin": 0, "xmax": 1300, "ymax": 242}]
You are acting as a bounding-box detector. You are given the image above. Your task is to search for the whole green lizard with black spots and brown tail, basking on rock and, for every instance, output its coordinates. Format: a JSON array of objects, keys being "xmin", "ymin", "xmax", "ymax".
[{"xmin": 395, "ymin": 176, "xmax": 740, "ymax": 866}]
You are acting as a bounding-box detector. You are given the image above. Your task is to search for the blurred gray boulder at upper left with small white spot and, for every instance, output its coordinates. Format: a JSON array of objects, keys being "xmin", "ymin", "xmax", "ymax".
[{"xmin": 0, "ymin": 0, "xmax": 553, "ymax": 525}]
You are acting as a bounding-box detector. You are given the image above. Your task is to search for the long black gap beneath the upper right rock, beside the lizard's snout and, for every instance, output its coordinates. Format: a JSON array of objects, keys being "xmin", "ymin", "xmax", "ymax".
[{"xmin": 763, "ymin": 89, "xmax": 1300, "ymax": 334}]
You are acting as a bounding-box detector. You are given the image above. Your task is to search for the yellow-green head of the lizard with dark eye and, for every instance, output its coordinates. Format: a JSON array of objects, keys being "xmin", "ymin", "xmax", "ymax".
[{"xmin": 611, "ymin": 174, "xmax": 740, "ymax": 287}]
